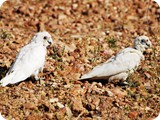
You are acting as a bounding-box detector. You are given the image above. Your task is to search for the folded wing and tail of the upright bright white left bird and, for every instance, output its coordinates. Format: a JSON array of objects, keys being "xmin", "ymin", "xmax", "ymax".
[{"xmin": 1, "ymin": 44, "xmax": 46, "ymax": 86}]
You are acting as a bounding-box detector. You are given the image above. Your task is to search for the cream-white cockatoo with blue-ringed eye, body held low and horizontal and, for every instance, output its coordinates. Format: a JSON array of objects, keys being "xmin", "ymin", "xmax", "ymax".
[{"xmin": 80, "ymin": 36, "xmax": 151, "ymax": 83}]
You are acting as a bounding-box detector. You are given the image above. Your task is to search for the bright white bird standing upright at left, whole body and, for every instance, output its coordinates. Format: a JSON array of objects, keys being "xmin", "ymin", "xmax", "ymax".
[{"xmin": 0, "ymin": 31, "xmax": 53, "ymax": 86}]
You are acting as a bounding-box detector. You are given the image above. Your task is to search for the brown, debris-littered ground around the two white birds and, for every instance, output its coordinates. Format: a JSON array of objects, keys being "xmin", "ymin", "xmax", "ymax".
[{"xmin": 0, "ymin": 0, "xmax": 160, "ymax": 120}]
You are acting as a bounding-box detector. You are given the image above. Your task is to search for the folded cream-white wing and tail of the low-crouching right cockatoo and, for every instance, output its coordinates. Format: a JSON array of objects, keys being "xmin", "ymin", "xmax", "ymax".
[{"xmin": 81, "ymin": 48, "xmax": 143, "ymax": 79}]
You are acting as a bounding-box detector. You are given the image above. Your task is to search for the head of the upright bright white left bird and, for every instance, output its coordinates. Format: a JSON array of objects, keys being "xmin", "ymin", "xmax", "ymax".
[{"xmin": 31, "ymin": 31, "xmax": 53, "ymax": 47}]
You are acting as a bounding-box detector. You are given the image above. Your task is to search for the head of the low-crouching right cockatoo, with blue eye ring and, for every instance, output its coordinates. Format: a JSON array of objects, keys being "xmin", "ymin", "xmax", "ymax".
[{"xmin": 134, "ymin": 36, "xmax": 152, "ymax": 53}]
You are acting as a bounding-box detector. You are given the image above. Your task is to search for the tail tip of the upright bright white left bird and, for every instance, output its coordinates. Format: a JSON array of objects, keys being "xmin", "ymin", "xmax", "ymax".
[{"xmin": 0, "ymin": 73, "xmax": 14, "ymax": 86}]
